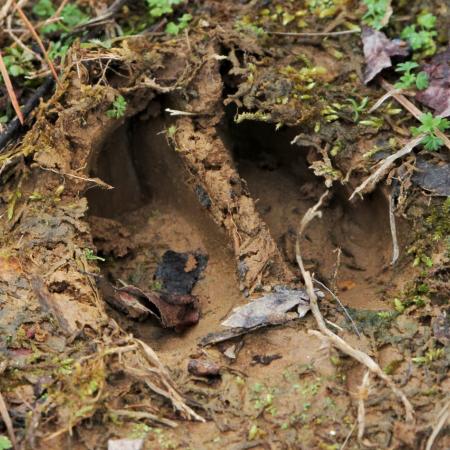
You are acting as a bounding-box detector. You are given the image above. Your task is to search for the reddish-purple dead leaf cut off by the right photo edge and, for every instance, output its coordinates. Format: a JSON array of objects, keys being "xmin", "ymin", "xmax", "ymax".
[{"xmin": 416, "ymin": 48, "xmax": 450, "ymax": 117}]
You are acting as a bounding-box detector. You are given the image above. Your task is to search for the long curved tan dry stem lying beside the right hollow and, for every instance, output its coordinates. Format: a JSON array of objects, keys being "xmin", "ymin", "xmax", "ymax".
[{"xmin": 296, "ymin": 197, "xmax": 414, "ymax": 422}]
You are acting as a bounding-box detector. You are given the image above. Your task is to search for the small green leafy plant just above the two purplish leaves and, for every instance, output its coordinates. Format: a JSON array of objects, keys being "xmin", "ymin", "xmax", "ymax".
[{"xmin": 400, "ymin": 13, "xmax": 437, "ymax": 57}]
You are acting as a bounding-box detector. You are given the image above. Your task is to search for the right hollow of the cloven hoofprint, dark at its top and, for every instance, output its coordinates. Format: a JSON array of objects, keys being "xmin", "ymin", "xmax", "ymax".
[{"xmin": 223, "ymin": 111, "xmax": 398, "ymax": 309}]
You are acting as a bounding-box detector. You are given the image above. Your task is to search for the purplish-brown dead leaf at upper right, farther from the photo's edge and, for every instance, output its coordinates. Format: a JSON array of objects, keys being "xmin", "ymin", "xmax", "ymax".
[{"xmin": 362, "ymin": 27, "xmax": 408, "ymax": 84}]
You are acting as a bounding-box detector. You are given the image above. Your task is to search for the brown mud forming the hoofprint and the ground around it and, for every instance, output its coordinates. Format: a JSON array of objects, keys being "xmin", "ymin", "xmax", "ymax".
[{"xmin": 0, "ymin": 8, "xmax": 449, "ymax": 450}]
